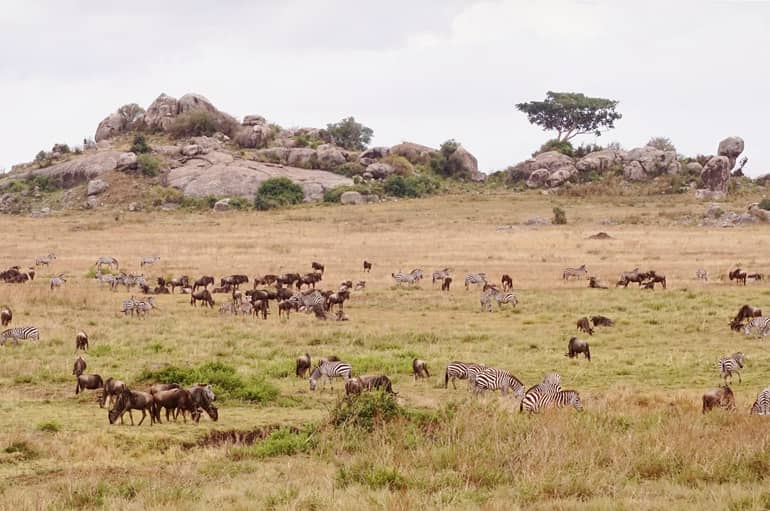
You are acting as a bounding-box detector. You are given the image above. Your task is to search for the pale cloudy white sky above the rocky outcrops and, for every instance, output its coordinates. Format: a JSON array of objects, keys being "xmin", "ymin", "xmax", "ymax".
[{"xmin": 0, "ymin": 0, "xmax": 770, "ymax": 176}]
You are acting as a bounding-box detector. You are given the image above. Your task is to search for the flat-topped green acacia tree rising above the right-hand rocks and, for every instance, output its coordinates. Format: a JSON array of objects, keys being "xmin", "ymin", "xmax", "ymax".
[{"xmin": 516, "ymin": 91, "xmax": 623, "ymax": 141}]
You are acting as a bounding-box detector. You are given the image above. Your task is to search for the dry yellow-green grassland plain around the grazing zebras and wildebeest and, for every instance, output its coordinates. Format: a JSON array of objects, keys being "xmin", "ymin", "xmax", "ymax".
[{"xmin": 0, "ymin": 193, "xmax": 770, "ymax": 510}]
